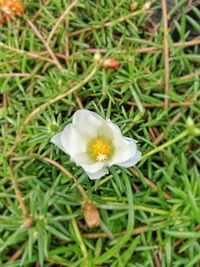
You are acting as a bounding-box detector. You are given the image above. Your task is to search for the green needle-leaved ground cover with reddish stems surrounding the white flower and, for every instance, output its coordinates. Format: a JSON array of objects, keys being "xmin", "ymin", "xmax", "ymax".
[{"xmin": 0, "ymin": 0, "xmax": 200, "ymax": 267}]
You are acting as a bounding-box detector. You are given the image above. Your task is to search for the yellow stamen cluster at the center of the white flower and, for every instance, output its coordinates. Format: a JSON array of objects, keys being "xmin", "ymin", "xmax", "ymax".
[{"xmin": 89, "ymin": 138, "xmax": 112, "ymax": 162}]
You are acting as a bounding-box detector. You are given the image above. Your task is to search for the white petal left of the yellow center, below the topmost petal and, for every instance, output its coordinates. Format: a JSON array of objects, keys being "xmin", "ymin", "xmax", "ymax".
[{"xmin": 60, "ymin": 124, "xmax": 87, "ymax": 158}]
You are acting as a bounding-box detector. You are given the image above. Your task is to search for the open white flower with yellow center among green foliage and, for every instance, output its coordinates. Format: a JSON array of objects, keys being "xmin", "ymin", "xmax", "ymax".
[{"xmin": 51, "ymin": 109, "xmax": 141, "ymax": 179}]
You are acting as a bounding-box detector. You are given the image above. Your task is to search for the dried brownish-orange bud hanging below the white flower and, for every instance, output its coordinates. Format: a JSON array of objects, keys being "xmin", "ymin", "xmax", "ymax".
[{"xmin": 83, "ymin": 202, "xmax": 100, "ymax": 228}]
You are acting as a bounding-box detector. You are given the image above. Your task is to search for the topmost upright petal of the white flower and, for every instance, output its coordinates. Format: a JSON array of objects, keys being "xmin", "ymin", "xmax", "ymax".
[{"xmin": 72, "ymin": 109, "xmax": 105, "ymax": 137}]
